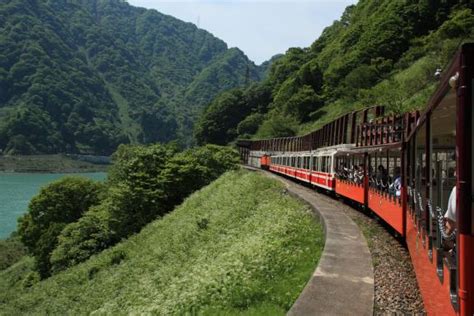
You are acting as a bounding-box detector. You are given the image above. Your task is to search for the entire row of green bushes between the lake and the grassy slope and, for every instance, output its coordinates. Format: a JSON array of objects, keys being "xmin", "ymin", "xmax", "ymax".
[{"xmin": 12, "ymin": 144, "xmax": 239, "ymax": 278}]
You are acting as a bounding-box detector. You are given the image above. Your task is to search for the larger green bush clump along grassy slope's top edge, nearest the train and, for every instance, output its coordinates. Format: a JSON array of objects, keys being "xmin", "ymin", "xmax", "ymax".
[{"xmin": 50, "ymin": 145, "xmax": 238, "ymax": 272}]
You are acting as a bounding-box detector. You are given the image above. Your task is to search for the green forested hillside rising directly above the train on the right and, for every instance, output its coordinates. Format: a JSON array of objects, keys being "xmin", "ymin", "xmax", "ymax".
[{"xmin": 195, "ymin": 0, "xmax": 474, "ymax": 144}]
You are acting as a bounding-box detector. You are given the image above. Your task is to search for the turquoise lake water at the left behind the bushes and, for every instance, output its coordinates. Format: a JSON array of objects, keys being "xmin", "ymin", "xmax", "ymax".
[{"xmin": 0, "ymin": 172, "xmax": 107, "ymax": 239}]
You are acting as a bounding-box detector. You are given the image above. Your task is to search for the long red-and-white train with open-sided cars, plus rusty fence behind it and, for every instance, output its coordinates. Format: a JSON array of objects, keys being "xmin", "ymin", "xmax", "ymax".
[{"xmin": 237, "ymin": 43, "xmax": 474, "ymax": 315}]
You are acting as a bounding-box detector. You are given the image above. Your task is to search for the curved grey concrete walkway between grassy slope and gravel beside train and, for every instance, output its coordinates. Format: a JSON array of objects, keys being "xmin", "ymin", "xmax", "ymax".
[{"xmin": 252, "ymin": 172, "xmax": 374, "ymax": 316}]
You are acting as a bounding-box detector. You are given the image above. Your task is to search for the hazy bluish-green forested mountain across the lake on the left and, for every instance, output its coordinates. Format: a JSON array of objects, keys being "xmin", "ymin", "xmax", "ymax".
[{"xmin": 0, "ymin": 0, "xmax": 264, "ymax": 154}]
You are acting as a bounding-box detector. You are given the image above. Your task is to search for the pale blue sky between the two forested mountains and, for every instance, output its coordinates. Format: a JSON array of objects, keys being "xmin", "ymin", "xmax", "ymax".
[{"xmin": 128, "ymin": 0, "xmax": 357, "ymax": 64}]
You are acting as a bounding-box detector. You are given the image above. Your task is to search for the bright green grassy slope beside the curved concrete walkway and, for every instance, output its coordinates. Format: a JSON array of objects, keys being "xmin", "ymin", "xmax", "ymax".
[{"xmin": 0, "ymin": 171, "xmax": 323, "ymax": 315}]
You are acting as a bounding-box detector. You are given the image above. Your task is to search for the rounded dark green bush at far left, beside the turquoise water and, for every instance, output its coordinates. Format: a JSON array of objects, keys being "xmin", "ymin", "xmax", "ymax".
[{"xmin": 18, "ymin": 177, "xmax": 103, "ymax": 277}]
